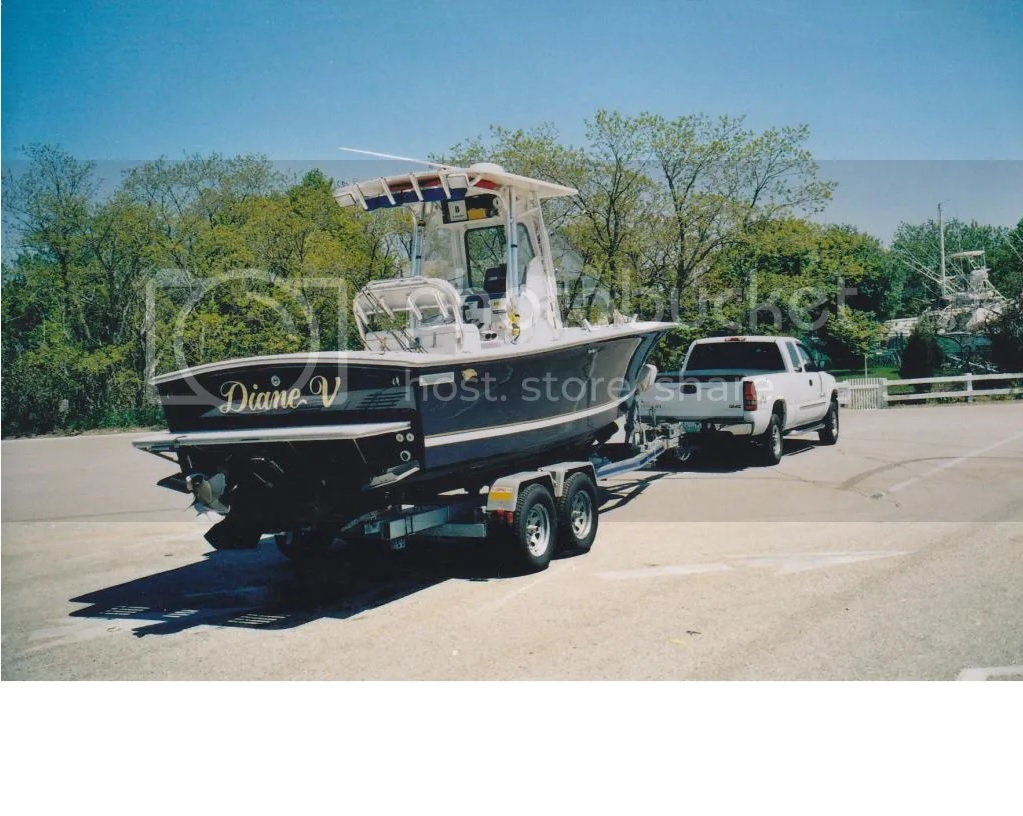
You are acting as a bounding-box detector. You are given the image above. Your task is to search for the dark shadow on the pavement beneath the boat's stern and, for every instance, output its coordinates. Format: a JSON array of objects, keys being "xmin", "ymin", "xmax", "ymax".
[{"xmin": 71, "ymin": 537, "xmax": 560, "ymax": 637}]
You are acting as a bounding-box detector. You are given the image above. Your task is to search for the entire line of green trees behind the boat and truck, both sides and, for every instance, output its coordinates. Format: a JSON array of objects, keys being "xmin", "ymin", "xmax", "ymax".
[{"xmin": 2, "ymin": 116, "xmax": 1023, "ymax": 434}]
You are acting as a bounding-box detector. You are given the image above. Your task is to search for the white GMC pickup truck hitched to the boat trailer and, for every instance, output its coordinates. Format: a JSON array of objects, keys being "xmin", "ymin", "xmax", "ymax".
[{"xmin": 639, "ymin": 336, "xmax": 838, "ymax": 464}]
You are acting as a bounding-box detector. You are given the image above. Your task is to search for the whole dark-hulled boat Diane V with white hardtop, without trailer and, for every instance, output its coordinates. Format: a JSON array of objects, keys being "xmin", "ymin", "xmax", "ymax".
[{"xmin": 133, "ymin": 163, "xmax": 675, "ymax": 548}]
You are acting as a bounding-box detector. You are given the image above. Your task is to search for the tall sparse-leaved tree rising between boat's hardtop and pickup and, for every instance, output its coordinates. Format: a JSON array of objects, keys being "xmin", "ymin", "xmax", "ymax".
[{"xmin": 450, "ymin": 110, "xmax": 834, "ymax": 325}]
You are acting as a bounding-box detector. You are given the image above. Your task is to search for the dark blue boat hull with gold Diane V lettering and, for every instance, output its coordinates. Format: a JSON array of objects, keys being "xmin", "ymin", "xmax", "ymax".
[{"xmin": 149, "ymin": 328, "xmax": 664, "ymax": 530}]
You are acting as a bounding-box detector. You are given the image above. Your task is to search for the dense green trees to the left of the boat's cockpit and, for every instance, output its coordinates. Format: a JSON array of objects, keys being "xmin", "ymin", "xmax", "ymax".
[{"xmin": 2, "ymin": 145, "xmax": 404, "ymax": 434}]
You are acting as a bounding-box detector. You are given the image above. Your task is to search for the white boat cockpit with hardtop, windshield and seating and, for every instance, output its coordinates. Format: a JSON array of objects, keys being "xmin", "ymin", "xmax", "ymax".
[{"xmin": 335, "ymin": 164, "xmax": 576, "ymax": 354}]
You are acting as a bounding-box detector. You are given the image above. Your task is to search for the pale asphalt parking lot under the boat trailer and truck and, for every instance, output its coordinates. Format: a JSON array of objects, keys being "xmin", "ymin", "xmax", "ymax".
[{"xmin": 2, "ymin": 402, "xmax": 1023, "ymax": 680}]
